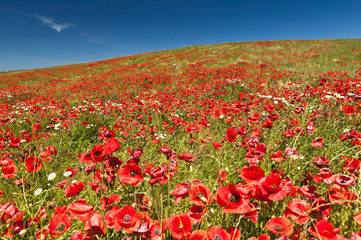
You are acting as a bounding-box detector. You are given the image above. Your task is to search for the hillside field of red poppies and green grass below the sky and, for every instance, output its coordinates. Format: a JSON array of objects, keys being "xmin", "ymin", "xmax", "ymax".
[{"xmin": 0, "ymin": 39, "xmax": 361, "ymax": 240}]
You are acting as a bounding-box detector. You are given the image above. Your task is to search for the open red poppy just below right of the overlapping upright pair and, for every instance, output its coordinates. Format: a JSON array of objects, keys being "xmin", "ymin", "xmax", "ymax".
[{"xmin": 118, "ymin": 163, "xmax": 144, "ymax": 186}]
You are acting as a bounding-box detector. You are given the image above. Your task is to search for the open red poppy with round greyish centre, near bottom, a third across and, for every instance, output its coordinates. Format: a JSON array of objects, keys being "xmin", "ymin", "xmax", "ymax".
[{"xmin": 114, "ymin": 205, "xmax": 141, "ymax": 233}]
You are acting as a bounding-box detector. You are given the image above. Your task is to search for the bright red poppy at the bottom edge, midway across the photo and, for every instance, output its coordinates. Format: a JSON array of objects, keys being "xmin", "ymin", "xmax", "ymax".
[{"xmin": 166, "ymin": 213, "xmax": 192, "ymax": 238}]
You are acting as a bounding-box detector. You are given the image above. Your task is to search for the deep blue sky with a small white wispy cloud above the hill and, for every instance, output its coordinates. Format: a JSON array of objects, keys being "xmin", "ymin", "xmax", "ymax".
[{"xmin": 0, "ymin": 0, "xmax": 361, "ymax": 71}]
